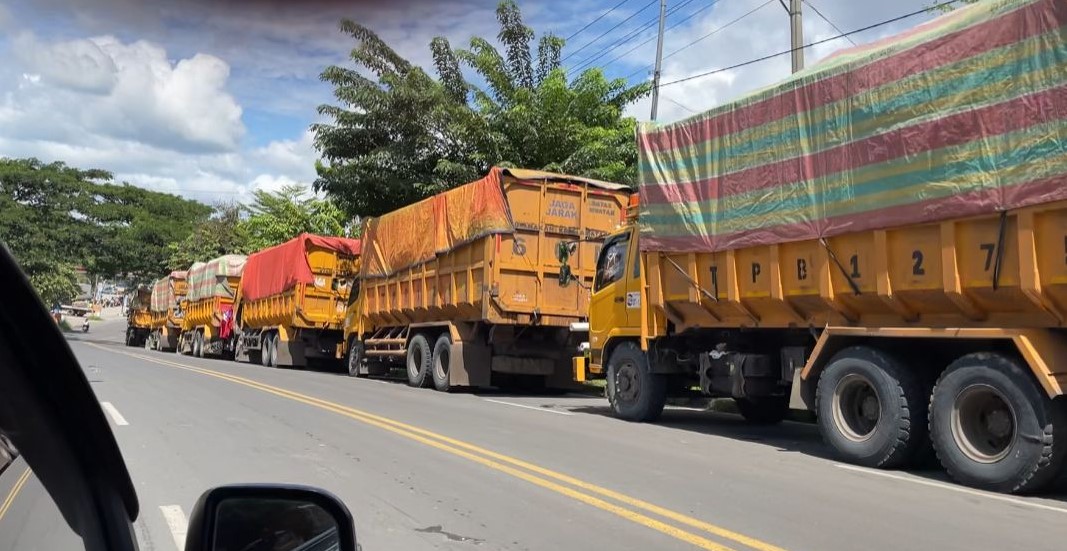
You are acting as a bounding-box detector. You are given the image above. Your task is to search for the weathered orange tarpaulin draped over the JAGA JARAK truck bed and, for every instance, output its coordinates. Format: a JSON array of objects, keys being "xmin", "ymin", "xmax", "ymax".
[{"xmin": 363, "ymin": 163, "xmax": 514, "ymax": 278}]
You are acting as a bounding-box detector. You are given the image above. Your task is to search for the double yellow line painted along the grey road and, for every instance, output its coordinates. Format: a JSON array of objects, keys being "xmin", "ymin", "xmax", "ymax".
[{"xmin": 85, "ymin": 343, "xmax": 784, "ymax": 551}]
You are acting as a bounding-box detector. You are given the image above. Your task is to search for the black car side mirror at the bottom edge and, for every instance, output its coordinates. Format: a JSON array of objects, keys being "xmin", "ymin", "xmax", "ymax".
[{"xmin": 186, "ymin": 484, "xmax": 356, "ymax": 551}]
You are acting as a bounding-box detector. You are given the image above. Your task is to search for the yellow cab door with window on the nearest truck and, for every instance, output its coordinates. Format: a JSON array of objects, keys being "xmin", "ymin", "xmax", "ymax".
[{"xmin": 589, "ymin": 232, "xmax": 634, "ymax": 354}]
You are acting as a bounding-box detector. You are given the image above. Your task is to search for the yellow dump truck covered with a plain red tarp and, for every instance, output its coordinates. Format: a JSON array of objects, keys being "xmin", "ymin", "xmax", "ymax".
[{"xmin": 234, "ymin": 234, "xmax": 360, "ymax": 366}]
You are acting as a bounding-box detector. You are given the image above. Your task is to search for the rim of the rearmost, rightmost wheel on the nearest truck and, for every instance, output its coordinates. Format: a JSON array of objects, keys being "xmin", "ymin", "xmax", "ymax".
[{"xmin": 950, "ymin": 384, "xmax": 1018, "ymax": 463}]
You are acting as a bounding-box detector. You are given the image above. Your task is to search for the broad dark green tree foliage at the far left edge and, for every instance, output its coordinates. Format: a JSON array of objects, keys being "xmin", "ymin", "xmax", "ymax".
[{"xmin": 0, "ymin": 159, "xmax": 210, "ymax": 301}]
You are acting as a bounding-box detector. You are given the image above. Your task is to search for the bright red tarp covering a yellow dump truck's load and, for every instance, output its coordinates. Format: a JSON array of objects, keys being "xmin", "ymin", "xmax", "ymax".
[{"xmin": 241, "ymin": 234, "xmax": 360, "ymax": 300}]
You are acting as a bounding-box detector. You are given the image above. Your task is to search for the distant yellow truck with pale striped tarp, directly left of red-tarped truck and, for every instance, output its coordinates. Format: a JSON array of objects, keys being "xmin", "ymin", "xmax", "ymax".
[{"xmin": 178, "ymin": 254, "xmax": 246, "ymax": 358}]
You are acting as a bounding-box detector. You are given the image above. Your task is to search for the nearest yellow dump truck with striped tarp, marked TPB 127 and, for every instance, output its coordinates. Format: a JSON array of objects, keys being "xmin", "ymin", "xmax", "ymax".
[{"xmin": 561, "ymin": 0, "xmax": 1067, "ymax": 492}]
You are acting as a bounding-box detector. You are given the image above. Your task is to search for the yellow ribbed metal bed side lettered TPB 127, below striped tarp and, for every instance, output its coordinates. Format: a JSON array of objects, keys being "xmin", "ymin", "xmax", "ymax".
[{"xmin": 642, "ymin": 202, "xmax": 1067, "ymax": 334}]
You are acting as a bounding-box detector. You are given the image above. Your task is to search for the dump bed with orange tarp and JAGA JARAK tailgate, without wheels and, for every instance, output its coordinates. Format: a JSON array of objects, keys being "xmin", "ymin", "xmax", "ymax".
[{"xmin": 361, "ymin": 169, "xmax": 630, "ymax": 329}]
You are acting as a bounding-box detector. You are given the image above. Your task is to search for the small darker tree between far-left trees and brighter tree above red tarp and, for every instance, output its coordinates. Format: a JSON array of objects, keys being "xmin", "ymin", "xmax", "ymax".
[{"xmin": 166, "ymin": 203, "xmax": 252, "ymax": 271}]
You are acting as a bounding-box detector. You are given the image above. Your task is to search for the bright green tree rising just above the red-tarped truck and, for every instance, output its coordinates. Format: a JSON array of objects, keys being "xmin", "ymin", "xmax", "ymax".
[{"xmin": 240, "ymin": 186, "xmax": 346, "ymax": 251}]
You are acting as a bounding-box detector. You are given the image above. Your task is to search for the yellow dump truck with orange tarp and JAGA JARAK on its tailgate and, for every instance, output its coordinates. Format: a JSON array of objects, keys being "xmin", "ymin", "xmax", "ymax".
[{"xmin": 345, "ymin": 169, "xmax": 630, "ymax": 391}]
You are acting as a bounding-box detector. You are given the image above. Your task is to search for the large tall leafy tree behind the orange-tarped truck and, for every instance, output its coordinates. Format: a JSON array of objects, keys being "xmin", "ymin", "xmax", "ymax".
[{"xmin": 312, "ymin": 0, "xmax": 650, "ymax": 216}]
